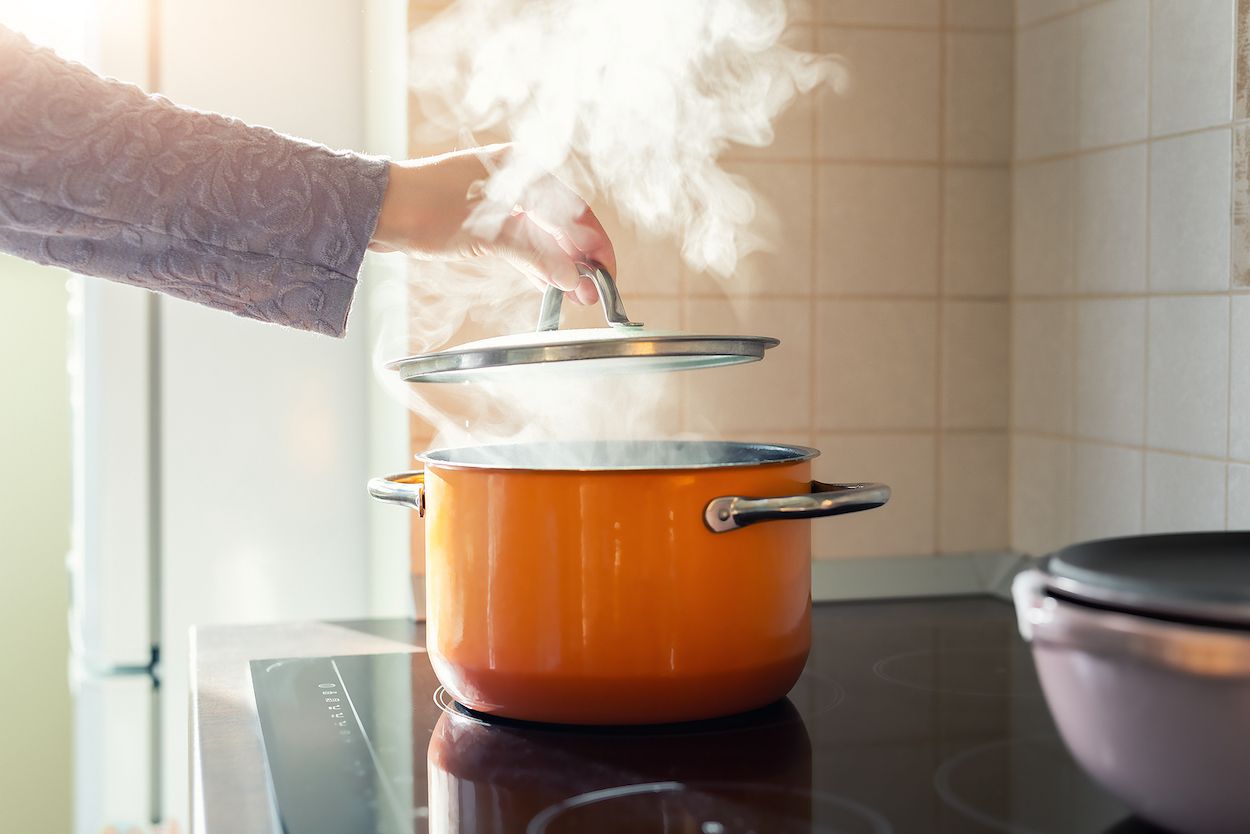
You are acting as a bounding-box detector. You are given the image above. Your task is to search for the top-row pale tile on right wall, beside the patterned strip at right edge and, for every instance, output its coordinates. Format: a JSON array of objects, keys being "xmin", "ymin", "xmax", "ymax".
[{"xmin": 1150, "ymin": 0, "xmax": 1235, "ymax": 135}]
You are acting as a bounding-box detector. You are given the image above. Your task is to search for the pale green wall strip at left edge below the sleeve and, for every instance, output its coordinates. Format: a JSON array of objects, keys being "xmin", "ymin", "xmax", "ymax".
[{"xmin": 0, "ymin": 256, "xmax": 71, "ymax": 833}]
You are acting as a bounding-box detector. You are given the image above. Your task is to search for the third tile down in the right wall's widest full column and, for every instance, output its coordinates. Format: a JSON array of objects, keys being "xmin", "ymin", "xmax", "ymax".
[{"xmin": 1146, "ymin": 298, "xmax": 1229, "ymax": 456}]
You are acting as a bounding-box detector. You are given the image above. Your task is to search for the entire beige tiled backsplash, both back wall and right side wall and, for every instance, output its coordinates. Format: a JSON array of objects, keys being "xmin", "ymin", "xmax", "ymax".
[{"xmin": 414, "ymin": 0, "xmax": 1250, "ymax": 567}]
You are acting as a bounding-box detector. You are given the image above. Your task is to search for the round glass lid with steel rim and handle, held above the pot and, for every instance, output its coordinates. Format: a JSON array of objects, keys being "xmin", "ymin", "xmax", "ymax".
[{"xmin": 386, "ymin": 264, "xmax": 780, "ymax": 383}]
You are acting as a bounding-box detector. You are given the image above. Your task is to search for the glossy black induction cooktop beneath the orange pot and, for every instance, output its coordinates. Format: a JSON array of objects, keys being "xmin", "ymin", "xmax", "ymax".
[{"xmin": 251, "ymin": 598, "xmax": 1159, "ymax": 834}]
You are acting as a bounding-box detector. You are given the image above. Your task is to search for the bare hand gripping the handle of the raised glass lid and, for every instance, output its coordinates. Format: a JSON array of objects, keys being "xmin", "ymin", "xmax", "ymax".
[{"xmin": 369, "ymin": 145, "xmax": 616, "ymax": 304}]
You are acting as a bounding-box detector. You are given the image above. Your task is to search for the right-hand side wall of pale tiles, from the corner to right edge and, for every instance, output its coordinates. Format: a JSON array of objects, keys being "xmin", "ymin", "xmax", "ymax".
[{"xmin": 1010, "ymin": 0, "xmax": 1250, "ymax": 553}]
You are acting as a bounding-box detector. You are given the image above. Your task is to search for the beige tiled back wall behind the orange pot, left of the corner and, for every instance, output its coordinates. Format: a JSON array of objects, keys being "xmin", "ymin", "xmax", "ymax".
[{"xmin": 414, "ymin": 0, "xmax": 1014, "ymax": 558}]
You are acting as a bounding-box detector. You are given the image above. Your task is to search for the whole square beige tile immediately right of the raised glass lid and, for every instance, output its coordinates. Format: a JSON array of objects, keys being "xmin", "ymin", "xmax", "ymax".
[{"xmin": 816, "ymin": 300, "xmax": 938, "ymax": 429}]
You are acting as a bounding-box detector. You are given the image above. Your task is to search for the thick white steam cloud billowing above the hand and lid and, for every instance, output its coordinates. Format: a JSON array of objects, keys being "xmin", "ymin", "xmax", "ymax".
[{"xmin": 410, "ymin": 0, "xmax": 845, "ymax": 276}]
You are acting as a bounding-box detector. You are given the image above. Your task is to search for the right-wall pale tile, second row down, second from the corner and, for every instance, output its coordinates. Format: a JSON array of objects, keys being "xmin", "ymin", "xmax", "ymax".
[{"xmin": 1076, "ymin": 145, "xmax": 1148, "ymax": 293}]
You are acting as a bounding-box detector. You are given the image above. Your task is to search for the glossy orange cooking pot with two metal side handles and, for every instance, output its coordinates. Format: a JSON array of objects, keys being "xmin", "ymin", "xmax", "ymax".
[{"xmin": 369, "ymin": 441, "xmax": 890, "ymax": 724}]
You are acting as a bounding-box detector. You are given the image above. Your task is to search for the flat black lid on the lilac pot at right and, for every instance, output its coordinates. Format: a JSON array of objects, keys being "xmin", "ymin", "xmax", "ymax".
[{"xmin": 1045, "ymin": 531, "xmax": 1250, "ymax": 628}]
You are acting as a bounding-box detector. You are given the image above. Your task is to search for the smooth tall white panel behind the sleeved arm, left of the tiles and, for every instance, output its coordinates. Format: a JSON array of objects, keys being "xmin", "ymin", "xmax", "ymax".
[{"xmin": 158, "ymin": 0, "xmax": 390, "ymax": 828}]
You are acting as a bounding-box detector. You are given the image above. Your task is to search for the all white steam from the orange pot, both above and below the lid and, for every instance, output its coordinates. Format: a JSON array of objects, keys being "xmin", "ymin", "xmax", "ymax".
[{"xmin": 375, "ymin": 0, "xmax": 845, "ymax": 465}]
